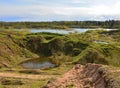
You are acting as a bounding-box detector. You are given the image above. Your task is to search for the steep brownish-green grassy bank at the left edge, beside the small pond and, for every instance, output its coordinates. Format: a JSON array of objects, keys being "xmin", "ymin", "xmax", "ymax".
[{"xmin": 0, "ymin": 31, "xmax": 38, "ymax": 67}]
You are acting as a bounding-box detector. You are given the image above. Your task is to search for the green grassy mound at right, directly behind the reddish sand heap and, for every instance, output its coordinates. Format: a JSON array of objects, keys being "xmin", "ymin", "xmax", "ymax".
[{"xmin": 75, "ymin": 44, "xmax": 120, "ymax": 66}]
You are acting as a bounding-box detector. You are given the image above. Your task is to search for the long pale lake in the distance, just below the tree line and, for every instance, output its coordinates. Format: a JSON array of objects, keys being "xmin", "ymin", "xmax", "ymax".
[{"xmin": 30, "ymin": 28, "xmax": 114, "ymax": 34}]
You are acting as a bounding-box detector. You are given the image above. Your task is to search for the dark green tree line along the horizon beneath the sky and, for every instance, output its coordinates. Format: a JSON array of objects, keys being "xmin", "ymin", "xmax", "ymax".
[{"xmin": 0, "ymin": 20, "xmax": 120, "ymax": 29}]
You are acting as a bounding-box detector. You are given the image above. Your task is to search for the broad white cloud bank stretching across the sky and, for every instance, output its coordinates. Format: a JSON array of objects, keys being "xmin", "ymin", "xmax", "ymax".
[{"xmin": 0, "ymin": 0, "xmax": 120, "ymax": 20}]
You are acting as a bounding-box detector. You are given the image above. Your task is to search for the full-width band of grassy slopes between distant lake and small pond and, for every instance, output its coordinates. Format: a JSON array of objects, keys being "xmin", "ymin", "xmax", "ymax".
[{"xmin": 0, "ymin": 30, "xmax": 120, "ymax": 66}]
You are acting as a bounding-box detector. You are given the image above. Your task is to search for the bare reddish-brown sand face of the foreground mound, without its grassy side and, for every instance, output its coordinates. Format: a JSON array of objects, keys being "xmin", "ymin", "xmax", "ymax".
[{"xmin": 43, "ymin": 64, "xmax": 106, "ymax": 88}]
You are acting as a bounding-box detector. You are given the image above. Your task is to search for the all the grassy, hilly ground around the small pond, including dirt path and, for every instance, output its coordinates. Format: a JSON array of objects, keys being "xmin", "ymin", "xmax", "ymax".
[{"xmin": 0, "ymin": 29, "xmax": 120, "ymax": 88}]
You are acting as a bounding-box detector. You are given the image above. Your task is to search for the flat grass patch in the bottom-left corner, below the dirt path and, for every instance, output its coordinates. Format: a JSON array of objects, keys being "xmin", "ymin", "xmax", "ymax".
[{"xmin": 0, "ymin": 78, "xmax": 49, "ymax": 88}]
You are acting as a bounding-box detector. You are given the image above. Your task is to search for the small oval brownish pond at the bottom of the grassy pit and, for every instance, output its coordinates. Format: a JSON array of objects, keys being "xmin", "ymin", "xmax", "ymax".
[{"xmin": 21, "ymin": 60, "xmax": 56, "ymax": 69}]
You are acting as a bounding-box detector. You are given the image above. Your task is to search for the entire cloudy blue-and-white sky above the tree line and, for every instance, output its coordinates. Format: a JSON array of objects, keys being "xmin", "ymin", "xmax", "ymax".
[{"xmin": 0, "ymin": 0, "xmax": 120, "ymax": 21}]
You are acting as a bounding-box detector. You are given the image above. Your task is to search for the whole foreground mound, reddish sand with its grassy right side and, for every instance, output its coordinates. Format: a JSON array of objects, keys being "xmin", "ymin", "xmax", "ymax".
[{"xmin": 43, "ymin": 64, "xmax": 120, "ymax": 88}]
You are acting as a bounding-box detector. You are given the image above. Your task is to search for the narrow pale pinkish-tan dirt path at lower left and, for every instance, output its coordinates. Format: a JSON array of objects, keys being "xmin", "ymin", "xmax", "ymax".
[{"xmin": 0, "ymin": 72, "xmax": 54, "ymax": 80}]
